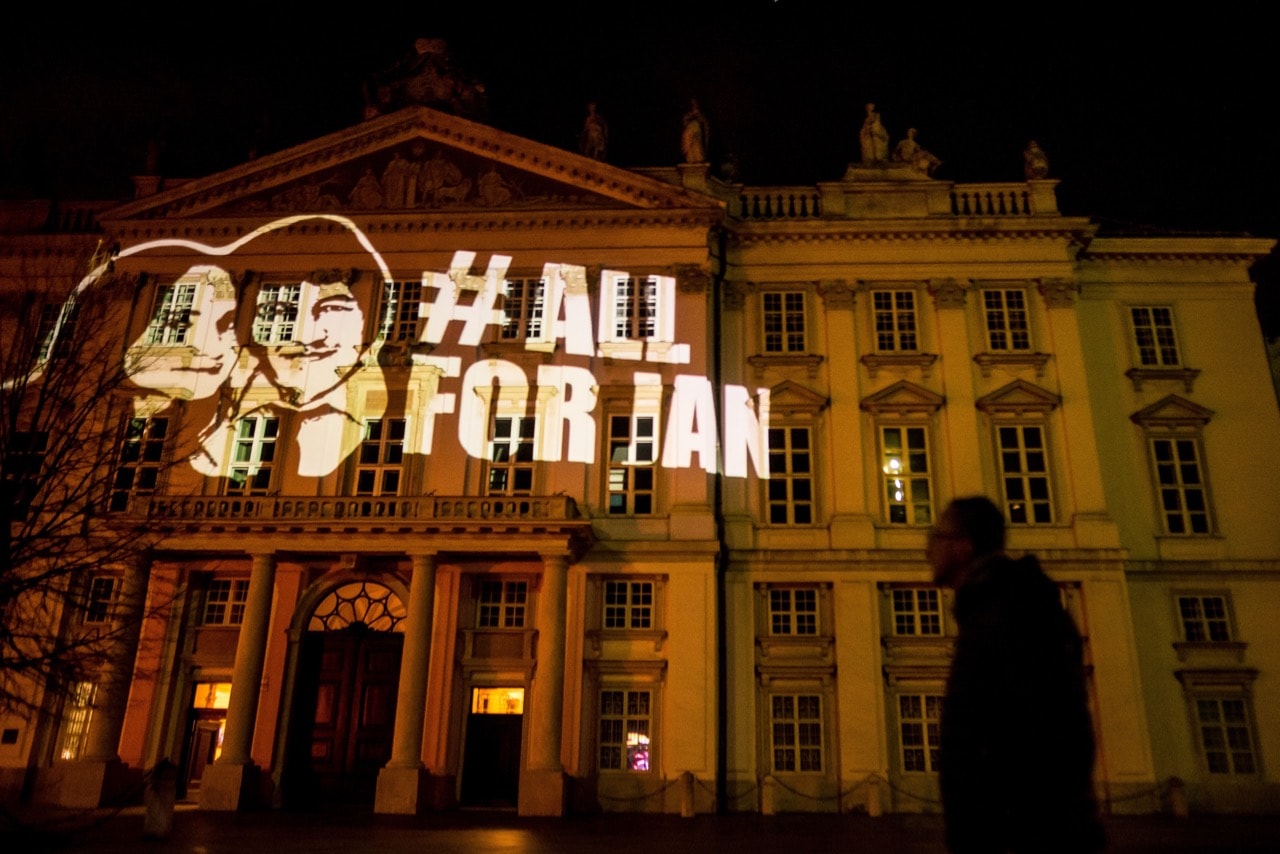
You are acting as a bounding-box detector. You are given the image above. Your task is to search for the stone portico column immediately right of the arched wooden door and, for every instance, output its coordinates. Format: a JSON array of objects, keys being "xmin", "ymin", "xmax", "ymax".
[{"xmin": 374, "ymin": 554, "xmax": 435, "ymax": 816}]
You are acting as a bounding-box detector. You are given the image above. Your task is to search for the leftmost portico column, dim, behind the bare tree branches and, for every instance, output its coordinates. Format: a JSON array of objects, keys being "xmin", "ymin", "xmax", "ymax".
[{"xmin": 58, "ymin": 558, "xmax": 151, "ymax": 808}]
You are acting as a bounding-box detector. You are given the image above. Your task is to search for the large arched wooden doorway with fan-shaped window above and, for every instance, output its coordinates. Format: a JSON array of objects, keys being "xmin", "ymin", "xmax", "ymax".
[{"xmin": 287, "ymin": 581, "xmax": 406, "ymax": 807}]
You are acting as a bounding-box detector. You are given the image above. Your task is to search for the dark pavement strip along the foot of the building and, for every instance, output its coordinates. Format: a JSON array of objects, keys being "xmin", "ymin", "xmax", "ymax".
[{"xmin": 0, "ymin": 807, "xmax": 1280, "ymax": 854}]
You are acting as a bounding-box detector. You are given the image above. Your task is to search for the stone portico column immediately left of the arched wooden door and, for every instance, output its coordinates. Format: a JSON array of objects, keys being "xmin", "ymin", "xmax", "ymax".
[{"xmin": 200, "ymin": 554, "xmax": 275, "ymax": 809}]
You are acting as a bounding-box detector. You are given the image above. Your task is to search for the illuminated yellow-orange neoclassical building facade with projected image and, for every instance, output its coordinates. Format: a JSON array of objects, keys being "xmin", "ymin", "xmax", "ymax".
[{"xmin": 0, "ymin": 108, "xmax": 1280, "ymax": 814}]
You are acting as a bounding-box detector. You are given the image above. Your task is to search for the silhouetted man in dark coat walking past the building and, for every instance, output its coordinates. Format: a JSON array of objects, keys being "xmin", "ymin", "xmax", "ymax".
[{"xmin": 928, "ymin": 497, "xmax": 1105, "ymax": 854}]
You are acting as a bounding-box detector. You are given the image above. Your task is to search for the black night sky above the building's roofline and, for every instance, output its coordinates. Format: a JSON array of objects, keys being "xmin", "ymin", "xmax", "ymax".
[{"xmin": 0, "ymin": 0, "xmax": 1280, "ymax": 335}]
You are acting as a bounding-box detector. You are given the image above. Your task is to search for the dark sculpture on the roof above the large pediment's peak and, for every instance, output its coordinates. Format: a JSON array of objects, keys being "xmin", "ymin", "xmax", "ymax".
[{"xmin": 365, "ymin": 38, "xmax": 486, "ymax": 119}]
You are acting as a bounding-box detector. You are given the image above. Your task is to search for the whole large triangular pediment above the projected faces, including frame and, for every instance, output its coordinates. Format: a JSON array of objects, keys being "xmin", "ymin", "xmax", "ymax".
[{"xmin": 102, "ymin": 106, "xmax": 721, "ymax": 220}]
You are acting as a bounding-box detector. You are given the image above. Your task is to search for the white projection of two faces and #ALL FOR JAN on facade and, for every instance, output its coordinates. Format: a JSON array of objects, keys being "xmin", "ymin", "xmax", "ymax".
[{"xmin": 30, "ymin": 214, "xmax": 768, "ymax": 481}]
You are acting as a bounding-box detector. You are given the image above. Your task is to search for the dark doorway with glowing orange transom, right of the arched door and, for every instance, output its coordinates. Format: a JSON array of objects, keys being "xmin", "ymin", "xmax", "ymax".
[{"xmin": 461, "ymin": 688, "xmax": 525, "ymax": 807}]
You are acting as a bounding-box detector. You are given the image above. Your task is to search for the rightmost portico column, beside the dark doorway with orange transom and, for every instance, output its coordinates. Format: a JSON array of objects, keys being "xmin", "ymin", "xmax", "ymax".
[{"xmin": 518, "ymin": 554, "xmax": 568, "ymax": 816}]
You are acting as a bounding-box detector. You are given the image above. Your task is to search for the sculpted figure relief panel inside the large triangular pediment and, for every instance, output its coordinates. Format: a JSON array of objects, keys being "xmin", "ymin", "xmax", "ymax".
[{"xmin": 236, "ymin": 141, "xmax": 608, "ymax": 214}]
